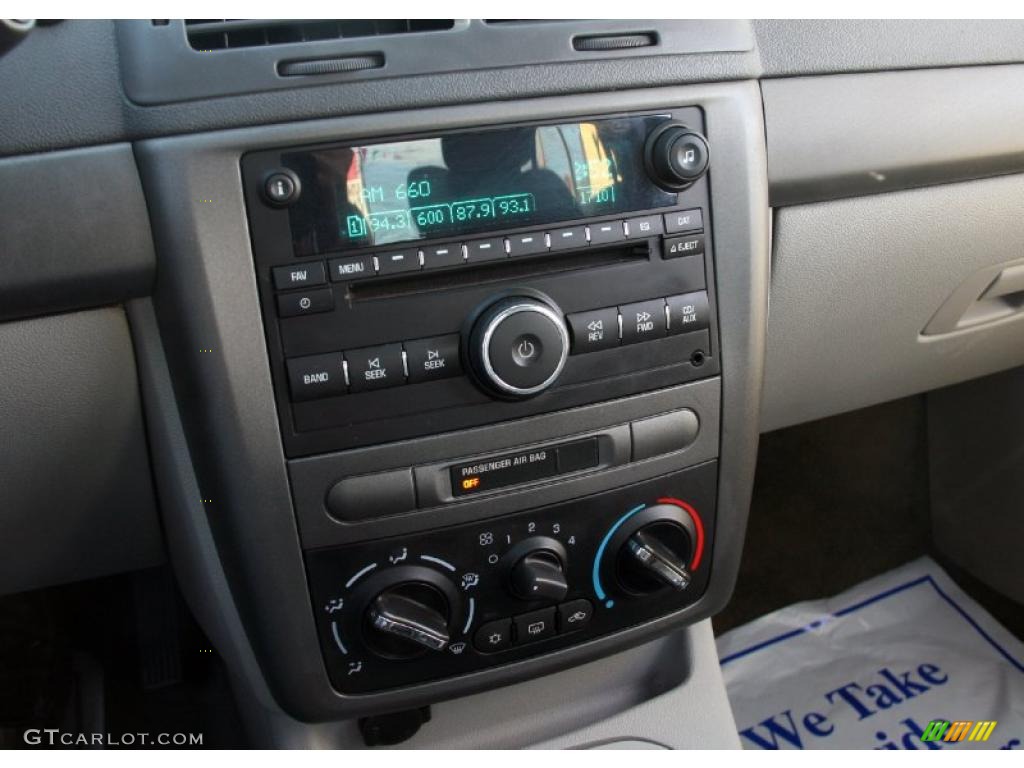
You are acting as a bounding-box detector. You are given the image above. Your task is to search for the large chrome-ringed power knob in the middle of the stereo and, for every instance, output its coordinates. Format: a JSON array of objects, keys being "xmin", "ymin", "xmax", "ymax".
[{"xmin": 468, "ymin": 296, "xmax": 569, "ymax": 398}]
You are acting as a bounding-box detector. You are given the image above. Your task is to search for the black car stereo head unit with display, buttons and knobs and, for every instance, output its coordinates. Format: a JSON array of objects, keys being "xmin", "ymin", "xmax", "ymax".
[{"xmin": 243, "ymin": 108, "xmax": 718, "ymax": 458}]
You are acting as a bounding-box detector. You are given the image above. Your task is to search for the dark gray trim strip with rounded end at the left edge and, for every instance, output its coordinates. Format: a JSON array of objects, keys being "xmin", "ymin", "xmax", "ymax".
[{"xmin": 0, "ymin": 144, "xmax": 157, "ymax": 319}]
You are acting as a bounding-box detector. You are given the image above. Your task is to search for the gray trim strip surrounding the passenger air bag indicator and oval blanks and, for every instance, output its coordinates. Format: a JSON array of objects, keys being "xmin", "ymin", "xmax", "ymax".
[{"xmin": 289, "ymin": 377, "xmax": 721, "ymax": 549}]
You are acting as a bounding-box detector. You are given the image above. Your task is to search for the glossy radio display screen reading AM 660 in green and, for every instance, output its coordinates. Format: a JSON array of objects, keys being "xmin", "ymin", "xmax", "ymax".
[{"xmin": 282, "ymin": 116, "xmax": 676, "ymax": 256}]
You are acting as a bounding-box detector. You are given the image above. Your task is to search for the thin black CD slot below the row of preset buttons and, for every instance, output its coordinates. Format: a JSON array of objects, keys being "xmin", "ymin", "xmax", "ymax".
[{"xmin": 348, "ymin": 241, "xmax": 650, "ymax": 302}]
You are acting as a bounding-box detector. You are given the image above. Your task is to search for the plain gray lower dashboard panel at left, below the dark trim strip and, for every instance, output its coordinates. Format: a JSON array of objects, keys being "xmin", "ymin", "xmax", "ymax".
[{"xmin": 0, "ymin": 307, "xmax": 164, "ymax": 594}]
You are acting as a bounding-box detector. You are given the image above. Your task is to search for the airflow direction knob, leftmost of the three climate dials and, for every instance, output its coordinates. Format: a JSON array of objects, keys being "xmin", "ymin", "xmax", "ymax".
[{"xmin": 366, "ymin": 582, "xmax": 452, "ymax": 658}]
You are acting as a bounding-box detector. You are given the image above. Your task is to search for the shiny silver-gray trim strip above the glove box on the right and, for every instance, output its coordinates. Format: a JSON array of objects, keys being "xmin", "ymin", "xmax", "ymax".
[{"xmin": 762, "ymin": 64, "xmax": 1024, "ymax": 206}]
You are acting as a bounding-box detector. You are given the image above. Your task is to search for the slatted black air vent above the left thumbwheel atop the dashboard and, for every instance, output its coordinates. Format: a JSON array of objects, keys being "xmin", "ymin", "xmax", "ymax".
[{"xmin": 185, "ymin": 18, "xmax": 455, "ymax": 51}]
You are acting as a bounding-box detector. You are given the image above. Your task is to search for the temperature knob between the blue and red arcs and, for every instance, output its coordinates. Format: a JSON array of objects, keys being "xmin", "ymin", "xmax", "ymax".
[{"xmin": 603, "ymin": 504, "xmax": 697, "ymax": 596}]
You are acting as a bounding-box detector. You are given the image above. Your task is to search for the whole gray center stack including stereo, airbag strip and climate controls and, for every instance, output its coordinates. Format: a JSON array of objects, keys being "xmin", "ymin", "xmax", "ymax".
[{"xmin": 132, "ymin": 84, "xmax": 767, "ymax": 720}]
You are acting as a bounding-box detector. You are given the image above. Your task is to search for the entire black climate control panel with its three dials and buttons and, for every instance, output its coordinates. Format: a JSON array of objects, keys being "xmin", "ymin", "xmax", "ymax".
[{"xmin": 306, "ymin": 461, "xmax": 718, "ymax": 694}]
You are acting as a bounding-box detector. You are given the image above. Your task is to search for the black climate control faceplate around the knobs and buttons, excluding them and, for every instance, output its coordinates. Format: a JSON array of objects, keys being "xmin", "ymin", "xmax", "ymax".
[{"xmin": 306, "ymin": 462, "xmax": 718, "ymax": 694}]
